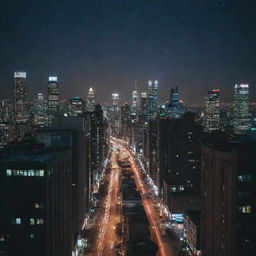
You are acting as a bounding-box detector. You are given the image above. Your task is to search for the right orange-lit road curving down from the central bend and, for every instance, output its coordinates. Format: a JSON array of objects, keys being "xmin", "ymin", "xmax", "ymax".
[{"xmin": 111, "ymin": 139, "xmax": 175, "ymax": 256}]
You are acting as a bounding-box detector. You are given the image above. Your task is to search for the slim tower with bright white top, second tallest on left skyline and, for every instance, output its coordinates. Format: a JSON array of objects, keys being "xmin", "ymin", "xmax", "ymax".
[{"xmin": 48, "ymin": 76, "xmax": 60, "ymax": 118}]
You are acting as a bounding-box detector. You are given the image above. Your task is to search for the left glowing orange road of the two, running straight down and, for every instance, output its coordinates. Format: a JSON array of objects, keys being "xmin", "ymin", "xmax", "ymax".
[{"xmin": 93, "ymin": 150, "xmax": 121, "ymax": 256}]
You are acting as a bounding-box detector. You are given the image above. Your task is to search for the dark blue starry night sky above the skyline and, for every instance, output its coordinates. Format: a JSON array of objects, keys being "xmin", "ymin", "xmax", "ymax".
[{"xmin": 0, "ymin": 0, "xmax": 256, "ymax": 103}]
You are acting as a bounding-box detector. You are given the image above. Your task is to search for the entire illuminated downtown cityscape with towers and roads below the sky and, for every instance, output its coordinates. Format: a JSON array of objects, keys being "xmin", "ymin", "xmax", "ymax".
[{"xmin": 0, "ymin": 72, "xmax": 256, "ymax": 256}]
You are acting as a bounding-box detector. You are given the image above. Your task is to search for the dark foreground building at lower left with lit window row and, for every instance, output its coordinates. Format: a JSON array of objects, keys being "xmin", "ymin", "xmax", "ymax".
[{"xmin": 0, "ymin": 143, "xmax": 72, "ymax": 256}]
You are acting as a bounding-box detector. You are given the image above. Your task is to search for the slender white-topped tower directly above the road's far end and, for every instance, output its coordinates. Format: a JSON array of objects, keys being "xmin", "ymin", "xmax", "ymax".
[{"xmin": 110, "ymin": 93, "xmax": 121, "ymax": 135}]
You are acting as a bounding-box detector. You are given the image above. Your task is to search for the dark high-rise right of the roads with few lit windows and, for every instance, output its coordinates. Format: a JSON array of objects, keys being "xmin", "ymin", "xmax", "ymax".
[{"xmin": 157, "ymin": 112, "xmax": 201, "ymax": 212}]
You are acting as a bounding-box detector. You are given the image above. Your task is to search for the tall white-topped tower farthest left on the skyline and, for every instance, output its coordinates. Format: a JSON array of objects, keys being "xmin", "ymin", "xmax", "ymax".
[{"xmin": 14, "ymin": 72, "xmax": 28, "ymax": 124}]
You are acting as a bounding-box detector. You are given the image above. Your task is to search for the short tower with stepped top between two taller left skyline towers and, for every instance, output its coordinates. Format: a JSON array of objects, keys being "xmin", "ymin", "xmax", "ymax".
[{"xmin": 34, "ymin": 93, "xmax": 48, "ymax": 127}]
